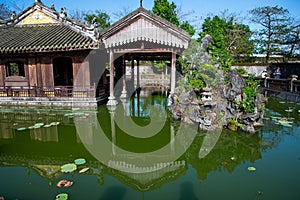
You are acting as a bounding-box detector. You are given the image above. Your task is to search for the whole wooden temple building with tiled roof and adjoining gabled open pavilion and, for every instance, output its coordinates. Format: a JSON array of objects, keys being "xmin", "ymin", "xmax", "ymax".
[{"xmin": 0, "ymin": 1, "xmax": 190, "ymax": 106}]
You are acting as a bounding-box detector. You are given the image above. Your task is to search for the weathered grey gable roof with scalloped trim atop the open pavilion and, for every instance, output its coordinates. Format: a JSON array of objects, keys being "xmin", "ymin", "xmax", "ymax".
[{"xmin": 100, "ymin": 8, "xmax": 190, "ymax": 49}]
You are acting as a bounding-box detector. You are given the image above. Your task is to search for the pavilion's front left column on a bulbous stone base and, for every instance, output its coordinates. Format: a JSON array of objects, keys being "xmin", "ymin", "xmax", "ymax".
[{"xmin": 107, "ymin": 50, "xmax": 118, "ymax": 106}]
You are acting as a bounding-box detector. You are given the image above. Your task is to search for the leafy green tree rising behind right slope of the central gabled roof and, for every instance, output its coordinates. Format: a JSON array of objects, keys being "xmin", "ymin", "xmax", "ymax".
[{"xmin": 152, "ymin": 0, "xmax": 195, "ymax": 36}]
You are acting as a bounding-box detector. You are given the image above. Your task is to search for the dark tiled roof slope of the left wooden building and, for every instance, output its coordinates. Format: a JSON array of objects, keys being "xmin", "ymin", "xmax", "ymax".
[{"xmin": 0, "ymin": 24, "xmax": 97, "ymax": 54}]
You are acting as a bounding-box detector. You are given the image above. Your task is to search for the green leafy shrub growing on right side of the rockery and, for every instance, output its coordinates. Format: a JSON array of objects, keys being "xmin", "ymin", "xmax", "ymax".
[{"xmin": 239, "ymin": 75, "xmax": 259, "ymax": 113}]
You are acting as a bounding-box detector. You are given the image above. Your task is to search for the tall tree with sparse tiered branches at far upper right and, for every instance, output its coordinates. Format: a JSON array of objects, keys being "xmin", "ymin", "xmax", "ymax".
[{"xmin": 250, "ymin": 6, "xmax": 291, "ymax": 61}]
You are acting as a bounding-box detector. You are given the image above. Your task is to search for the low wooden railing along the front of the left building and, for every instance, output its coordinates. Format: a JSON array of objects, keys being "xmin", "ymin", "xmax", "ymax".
[{"xmin": 0, "ymin": 86, "xmax": 96, "ymax": 98}]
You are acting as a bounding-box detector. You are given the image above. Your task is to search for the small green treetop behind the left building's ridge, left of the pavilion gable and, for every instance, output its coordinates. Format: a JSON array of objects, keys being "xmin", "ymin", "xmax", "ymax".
[{"xmin": 84, "ymin": 10, "xmax": 110, "ymax": 30}]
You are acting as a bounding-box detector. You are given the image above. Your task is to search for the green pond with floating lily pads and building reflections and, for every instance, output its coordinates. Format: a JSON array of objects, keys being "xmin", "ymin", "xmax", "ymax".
[{"xmin": 0, "ymin": 89, "xmax": 300, "ymax": 200}]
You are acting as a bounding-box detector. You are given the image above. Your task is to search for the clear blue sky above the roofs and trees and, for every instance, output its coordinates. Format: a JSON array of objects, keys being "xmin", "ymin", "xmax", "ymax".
[{"xmin": 0, "ymin": 0, "xmax": 300, "ymax": 30}]
